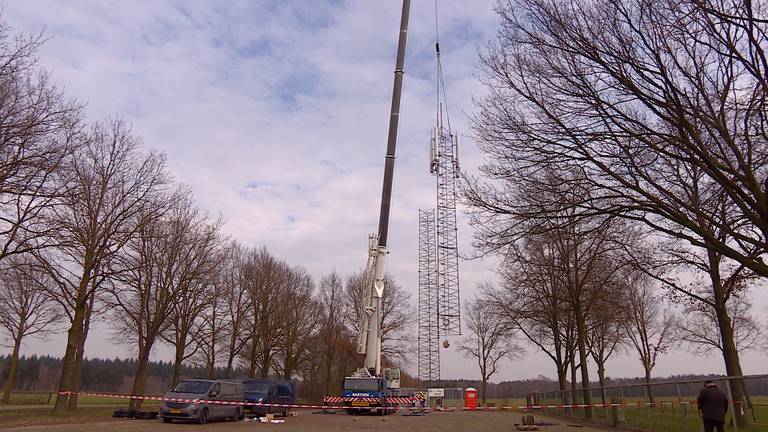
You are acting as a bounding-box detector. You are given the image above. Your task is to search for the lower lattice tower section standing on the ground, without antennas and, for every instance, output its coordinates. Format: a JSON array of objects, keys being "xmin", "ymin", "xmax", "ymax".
[{"xmin": 418, "ymin": 209, "xmax": 440, "ymax": 381}]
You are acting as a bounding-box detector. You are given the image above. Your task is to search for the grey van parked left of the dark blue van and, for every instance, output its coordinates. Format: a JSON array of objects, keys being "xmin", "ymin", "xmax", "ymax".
[{"xmin": 160, "ymin": 379, "xmax": 244, "ymax": 424}]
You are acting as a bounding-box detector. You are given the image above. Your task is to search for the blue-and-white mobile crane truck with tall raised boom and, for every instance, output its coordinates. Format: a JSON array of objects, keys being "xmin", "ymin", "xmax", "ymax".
[{"xmin": 342, "ymin": 0, "xmax": 411, "ymax": 415}]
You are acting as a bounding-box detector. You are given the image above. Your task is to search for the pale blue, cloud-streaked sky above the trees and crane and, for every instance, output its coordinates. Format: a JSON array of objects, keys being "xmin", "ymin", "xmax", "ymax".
[{"xmin": 0, "ymin": 0, "xmax": 768, "ymax": 381}]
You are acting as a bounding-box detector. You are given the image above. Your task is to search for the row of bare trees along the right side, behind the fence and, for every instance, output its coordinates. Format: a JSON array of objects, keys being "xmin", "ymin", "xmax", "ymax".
[{"xmin": 456, "ymin": 0, "xmax": 768, "ymax": 422}]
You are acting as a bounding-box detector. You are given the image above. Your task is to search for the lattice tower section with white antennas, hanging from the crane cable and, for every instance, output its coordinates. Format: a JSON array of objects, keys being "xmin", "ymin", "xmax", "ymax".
[{"xmin": 430, "ymin": 126, "xmax": 461, "ymax": 336}]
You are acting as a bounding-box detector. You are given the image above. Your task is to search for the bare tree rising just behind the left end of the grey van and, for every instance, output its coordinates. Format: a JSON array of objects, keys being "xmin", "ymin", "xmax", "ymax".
[{"xmin": 105, "ymin": 197, "xmax": 219, "ymax": 408}]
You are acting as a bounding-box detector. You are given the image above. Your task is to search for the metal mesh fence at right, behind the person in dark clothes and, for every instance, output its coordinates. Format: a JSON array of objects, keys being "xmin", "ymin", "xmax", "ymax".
[{"xmin": 528, "ymin": 375, "xmax": 768, "ymax": 432}]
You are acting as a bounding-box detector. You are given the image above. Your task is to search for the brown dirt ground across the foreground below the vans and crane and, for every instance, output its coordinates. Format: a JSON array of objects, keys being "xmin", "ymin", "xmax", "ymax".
[{"xmin": 8, "ymin": 411, "xmax": 608, "ymax": 432}]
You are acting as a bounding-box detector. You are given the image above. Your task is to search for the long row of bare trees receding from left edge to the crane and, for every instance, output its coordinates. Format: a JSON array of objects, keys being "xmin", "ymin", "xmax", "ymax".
[{"xmin": 0, "ymin": 21, "xmax": 413, "ymax": 413}]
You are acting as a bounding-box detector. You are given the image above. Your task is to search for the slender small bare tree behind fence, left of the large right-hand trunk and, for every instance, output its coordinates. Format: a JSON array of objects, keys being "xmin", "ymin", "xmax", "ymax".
[{"xmin": 626, "ymin": 274, "xmax": 674, "ymax": 403}]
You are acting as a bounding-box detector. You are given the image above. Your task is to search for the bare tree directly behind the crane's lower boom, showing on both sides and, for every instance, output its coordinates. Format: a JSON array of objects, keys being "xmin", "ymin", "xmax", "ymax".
[{"xmin": 344, "ymin": 270, "xmax": 416, "ymax": 365}]
